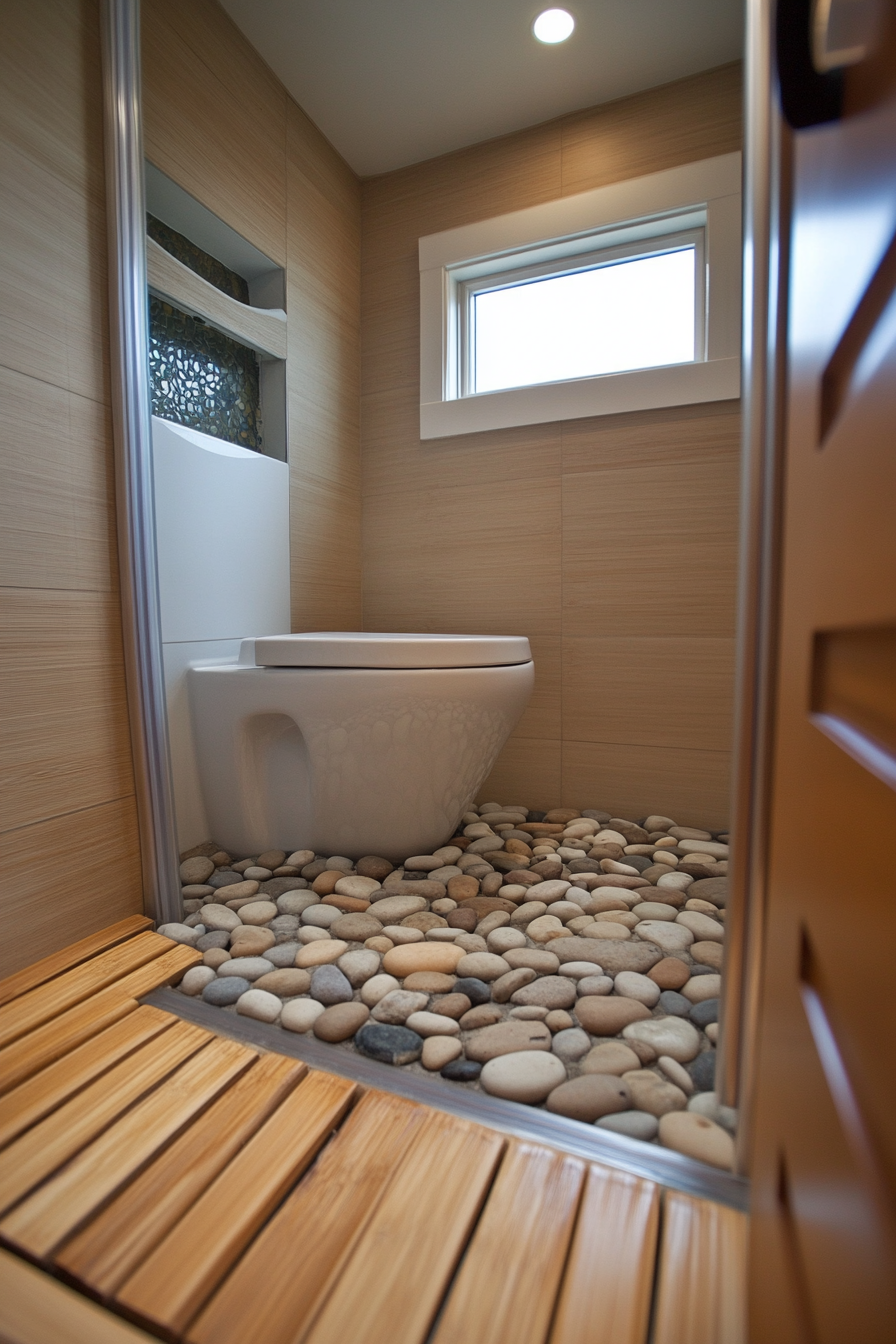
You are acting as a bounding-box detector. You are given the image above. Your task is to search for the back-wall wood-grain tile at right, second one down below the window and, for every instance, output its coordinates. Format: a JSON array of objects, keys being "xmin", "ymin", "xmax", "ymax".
[{"xmin": 563, "ymin": 456, "xmax": 739, "ymax": 636}]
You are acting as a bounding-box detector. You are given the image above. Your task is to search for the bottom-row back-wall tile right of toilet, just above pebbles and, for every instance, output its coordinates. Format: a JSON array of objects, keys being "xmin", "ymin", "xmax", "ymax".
[{"xmin": 564, "ymin": 739, "xmax": 731, "ymax": 831}]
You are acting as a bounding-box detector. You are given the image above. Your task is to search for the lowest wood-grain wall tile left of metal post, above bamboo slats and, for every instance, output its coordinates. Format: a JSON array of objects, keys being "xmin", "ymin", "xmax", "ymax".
[{"xmin": 0, "ymin": 796, "xmax": 142, "ymax": 976}]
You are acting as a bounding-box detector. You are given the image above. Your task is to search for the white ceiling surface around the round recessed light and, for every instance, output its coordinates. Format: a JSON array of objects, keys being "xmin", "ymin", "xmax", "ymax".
[{"xmin": 214, "ymin": 0, "xmax": 743, "ymax": 176}]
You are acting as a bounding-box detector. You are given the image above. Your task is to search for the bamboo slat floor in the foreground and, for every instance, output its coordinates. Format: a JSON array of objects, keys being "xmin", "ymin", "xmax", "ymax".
[{"xmin": 0, "ymin": 919, "xmax": 746, "ymax": 1344}]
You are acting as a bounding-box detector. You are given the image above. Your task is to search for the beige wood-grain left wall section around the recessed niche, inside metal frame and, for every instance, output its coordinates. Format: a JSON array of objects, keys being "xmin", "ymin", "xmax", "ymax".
[{"xmin": 142, "ymin": 0, "xmax": 361, "ymax": 630}]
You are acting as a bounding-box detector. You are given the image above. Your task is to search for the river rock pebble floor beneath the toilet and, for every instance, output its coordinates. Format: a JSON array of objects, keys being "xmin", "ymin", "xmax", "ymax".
[{"xmin": 160, "ymin": 802, "xmax": 736, "ymax": 1168}]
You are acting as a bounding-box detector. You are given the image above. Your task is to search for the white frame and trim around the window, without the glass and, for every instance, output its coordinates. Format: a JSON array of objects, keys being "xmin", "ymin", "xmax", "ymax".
[{"xmin": 419, "ymin": 153, "xmax": 742, "ymax": 439}]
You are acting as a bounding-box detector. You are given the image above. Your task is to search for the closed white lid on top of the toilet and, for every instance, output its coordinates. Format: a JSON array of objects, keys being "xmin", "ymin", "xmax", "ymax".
[{"xmin": 255, "ymin": 630, "xmax": 532, "ymax": 668}]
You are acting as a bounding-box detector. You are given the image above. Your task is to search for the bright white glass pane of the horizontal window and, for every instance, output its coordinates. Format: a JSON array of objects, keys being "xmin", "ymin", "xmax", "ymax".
[{"xmin": 472, "ymin": 247, "xmax": 696, "ymax": 392}]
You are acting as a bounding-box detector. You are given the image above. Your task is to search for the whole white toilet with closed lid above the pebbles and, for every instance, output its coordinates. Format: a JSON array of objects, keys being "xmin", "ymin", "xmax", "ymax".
[{"xmin": 188, "ymin": 633, "xmax": 535, "ymax": 860}]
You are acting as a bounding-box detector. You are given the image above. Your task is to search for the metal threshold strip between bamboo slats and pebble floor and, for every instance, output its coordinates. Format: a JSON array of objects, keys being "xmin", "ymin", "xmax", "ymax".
[{"xmin": 141, "ymin": 989, "xmax": 750, "ymax": 1212}]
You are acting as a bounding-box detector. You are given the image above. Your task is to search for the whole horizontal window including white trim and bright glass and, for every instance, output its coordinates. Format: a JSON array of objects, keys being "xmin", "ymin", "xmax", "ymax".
[{"xmin": 420, "ymin": 155, "xmax": 740, "ymax": 438}]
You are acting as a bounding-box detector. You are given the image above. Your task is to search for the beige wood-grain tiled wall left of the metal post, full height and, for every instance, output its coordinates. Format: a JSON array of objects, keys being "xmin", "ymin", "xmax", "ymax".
[{"xmin": 0, "ymin": 0, "xmax": 142, "ymax": 976}]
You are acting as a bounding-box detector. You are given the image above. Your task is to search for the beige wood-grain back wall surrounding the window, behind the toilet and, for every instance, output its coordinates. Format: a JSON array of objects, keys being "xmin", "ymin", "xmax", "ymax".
[{"xmin": 361, "ymin": 65, "xmax": 740, "ymax": 827}]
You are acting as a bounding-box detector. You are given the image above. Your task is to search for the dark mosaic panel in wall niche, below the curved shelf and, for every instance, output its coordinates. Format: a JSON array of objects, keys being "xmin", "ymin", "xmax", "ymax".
[{"xmin": 149, "ymin": 299, "xmax": 262, "ymax": 452}]
